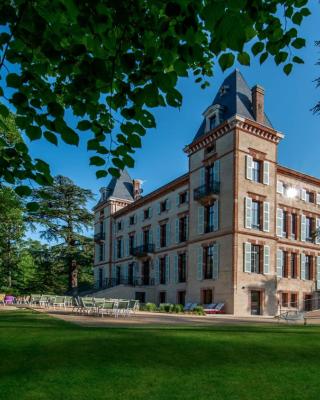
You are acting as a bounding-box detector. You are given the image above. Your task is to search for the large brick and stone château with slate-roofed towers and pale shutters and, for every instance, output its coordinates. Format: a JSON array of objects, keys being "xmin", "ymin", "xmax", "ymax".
[{"xmin": 94, "ymin": 70, "xmax": 320, "ymax": 315}]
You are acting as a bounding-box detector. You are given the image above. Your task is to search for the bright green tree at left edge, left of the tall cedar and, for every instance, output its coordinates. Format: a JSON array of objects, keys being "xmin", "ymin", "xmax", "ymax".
[{"xmin": 0, "ymin": 187, "xmax": 25, "ymax": 288}]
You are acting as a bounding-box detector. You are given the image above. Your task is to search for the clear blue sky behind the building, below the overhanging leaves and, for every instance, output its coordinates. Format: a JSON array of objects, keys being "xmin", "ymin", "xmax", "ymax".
[{"xmin": 26, "ymin": 0, "xmax": 320, "ymax": 234}]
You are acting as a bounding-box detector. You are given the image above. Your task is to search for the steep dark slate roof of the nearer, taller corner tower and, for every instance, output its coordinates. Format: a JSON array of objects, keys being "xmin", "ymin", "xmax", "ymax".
[{"xmin": 193, "ymin": 69, "xmax": 272, "ymax": 141}]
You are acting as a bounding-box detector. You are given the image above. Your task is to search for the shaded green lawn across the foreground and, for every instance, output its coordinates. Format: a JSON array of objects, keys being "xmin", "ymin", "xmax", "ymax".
[{"xmin": 0, "ymin": 311, "xmax": 320, "ymax": 400}]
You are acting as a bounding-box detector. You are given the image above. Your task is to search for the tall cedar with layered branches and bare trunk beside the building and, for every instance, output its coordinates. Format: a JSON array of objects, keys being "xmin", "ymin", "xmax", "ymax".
[{"xmin": 30, "ymin": 176, "xmax": 93, "ymax": 291}]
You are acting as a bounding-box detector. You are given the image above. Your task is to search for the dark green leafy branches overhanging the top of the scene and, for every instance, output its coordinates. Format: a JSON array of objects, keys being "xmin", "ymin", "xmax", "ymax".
[{"xmin": 0, "ymin": 0, "xmax": 310, "ymax": 188}]
